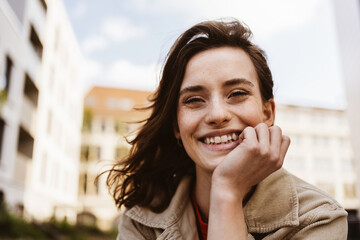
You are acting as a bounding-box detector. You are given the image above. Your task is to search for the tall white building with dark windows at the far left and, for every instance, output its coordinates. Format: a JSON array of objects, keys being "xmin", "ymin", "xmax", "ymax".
[{"xmin": 0, "ymin": 0, "xmax": 83, "ymax": 221}]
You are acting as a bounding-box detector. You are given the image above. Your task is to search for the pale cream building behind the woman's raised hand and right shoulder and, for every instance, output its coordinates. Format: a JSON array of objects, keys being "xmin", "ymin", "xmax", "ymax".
[{"xmin": 276, "ymin": 105, "xmax": 358, "ymax": 209}]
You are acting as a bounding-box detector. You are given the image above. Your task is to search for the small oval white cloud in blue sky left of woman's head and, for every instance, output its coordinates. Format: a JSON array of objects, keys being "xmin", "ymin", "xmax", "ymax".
[{"xmin": 101, "ymin": 17, "xmax": 145, "ymax": 43}]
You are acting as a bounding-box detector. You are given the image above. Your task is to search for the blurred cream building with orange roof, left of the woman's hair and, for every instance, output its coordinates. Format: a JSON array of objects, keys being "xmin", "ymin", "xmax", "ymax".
[{"xmin": 79, "ymin": 87, "xmax": 150, "ymax": 230}]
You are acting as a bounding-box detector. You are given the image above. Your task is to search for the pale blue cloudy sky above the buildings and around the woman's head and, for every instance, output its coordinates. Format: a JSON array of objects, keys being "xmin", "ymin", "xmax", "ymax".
[{"xmin": 63, "ymin": 0, "xmax": 346, "ymax": 109}]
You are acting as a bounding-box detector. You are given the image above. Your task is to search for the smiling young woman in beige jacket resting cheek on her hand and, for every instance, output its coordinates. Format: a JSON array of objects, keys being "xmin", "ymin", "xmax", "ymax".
[{"xmin": 108, "ymin": 20, "xmax": 347, "ymax": 240}]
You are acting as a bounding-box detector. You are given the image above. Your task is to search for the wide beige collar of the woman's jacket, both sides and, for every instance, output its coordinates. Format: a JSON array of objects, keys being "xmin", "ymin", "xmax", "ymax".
[{"xmin": 126, "ymin": 169, "xmax": 299, "ymax": 233}]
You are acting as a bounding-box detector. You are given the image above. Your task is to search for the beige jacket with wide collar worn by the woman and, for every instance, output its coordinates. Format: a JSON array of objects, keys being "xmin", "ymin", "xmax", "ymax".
[{"xmin": 117, "ymin": 169, "xmax": 347, "ymax": 240}]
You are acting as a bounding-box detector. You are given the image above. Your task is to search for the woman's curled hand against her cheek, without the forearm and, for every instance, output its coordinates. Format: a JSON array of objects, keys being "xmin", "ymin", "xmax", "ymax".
[{"xmin": 212, "ymin": 123, "xmax": 290, "ymax": 199}]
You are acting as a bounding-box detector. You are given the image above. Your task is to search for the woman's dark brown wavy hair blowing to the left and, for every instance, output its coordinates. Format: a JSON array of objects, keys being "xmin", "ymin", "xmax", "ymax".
[{"xmin": 107, "ymin": 19, "xmax": 273, "ymax": 212}]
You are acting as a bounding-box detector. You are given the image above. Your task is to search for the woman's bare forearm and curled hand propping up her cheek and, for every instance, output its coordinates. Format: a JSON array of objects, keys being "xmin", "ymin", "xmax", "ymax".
[{"xmin": 208, "ymin": 123, "xmax": 290, "ymax": 240}]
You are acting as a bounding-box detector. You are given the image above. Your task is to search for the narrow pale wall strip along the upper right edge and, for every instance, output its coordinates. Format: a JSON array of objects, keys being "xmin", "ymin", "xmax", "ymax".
[{"xmin": 332, "ymin": 0, "xmax": 360, "ymax": 216}]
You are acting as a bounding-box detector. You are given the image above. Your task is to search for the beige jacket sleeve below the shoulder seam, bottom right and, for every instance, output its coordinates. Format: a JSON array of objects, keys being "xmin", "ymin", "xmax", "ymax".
[{"xmin": 290, "ymin": 204, "xmax": 348, "ymax": 240}]
